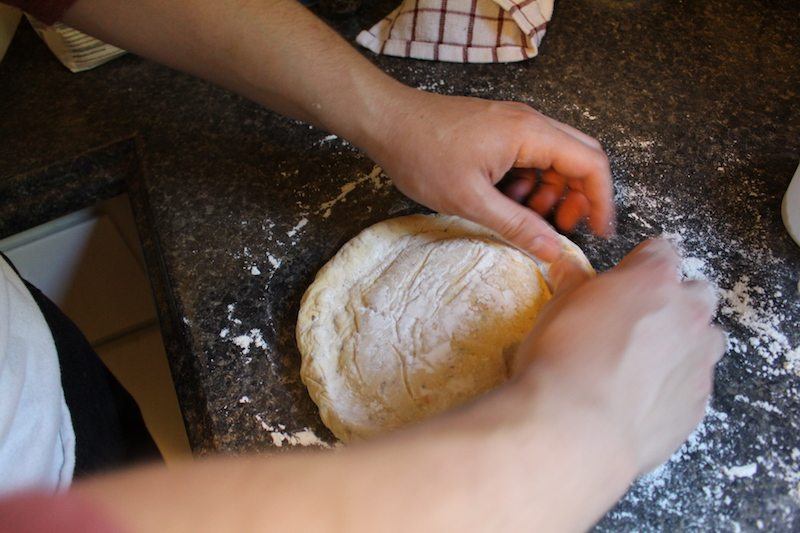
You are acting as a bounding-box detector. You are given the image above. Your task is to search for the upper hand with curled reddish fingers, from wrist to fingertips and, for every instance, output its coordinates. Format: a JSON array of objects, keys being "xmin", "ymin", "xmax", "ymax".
[{"xmin": 368, "ymin": 90, "xmax": 614, "ymax": 261}]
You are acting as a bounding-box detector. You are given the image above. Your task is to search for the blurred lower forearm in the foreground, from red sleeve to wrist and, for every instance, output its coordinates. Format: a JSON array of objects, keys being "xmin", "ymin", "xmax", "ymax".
[{"xmin": 76, "ymin": 384, "xmax": 630, "ymax": 532}]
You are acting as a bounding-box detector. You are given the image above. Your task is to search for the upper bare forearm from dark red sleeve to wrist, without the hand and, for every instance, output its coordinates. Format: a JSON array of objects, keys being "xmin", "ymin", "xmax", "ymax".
[{"xmin": 64, "ymin": 0, "xmax": 410, "ymax": 147}]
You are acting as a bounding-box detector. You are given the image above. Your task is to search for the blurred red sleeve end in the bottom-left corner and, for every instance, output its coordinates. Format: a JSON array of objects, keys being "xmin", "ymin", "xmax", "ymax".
[{"xmin": 0, "ymin": 492, "xmax": 122, "ymax": 533}]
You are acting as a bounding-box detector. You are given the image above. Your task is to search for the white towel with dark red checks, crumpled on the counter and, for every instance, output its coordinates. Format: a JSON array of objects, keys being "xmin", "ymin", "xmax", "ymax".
[{"xmin": 356, "ymin": 0, "xmax": 554, "ymax": 63}]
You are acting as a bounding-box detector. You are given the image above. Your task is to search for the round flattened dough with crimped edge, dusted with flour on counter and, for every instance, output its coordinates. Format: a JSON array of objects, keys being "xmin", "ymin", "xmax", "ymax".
[{"xmin": 297, "ymin": 215, "xmax": 591, "ymax": 442}]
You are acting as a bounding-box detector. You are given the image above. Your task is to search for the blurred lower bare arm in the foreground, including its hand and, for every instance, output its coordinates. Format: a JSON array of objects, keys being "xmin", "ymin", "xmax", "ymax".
[{"xmin": 75, "ymin": 241, "xmax": 724, "ymax": 533}]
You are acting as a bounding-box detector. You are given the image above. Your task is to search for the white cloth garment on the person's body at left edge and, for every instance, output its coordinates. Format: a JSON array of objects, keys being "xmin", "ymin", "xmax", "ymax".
[{"xmin": 0, "ymin": 258, "xmax": 75, "ymax": 495}]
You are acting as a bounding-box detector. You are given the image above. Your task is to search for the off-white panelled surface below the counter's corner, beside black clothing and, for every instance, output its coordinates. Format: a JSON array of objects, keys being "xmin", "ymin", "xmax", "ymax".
[{"xmin": 0, "ymin": 195, "xmax": 191, "ymax": 464}]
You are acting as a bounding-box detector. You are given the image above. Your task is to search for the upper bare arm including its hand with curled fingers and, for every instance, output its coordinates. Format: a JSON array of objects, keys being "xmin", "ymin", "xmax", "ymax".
[{"xmin": 64, "ymin": 0, "xmax": 614, "ymax": 260}]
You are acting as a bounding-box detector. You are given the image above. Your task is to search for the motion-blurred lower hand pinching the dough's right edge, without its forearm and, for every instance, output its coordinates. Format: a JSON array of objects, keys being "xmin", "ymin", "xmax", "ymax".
[{"xmin": 514, "ymin": 240, "xmax": 726, "ymax": 474}]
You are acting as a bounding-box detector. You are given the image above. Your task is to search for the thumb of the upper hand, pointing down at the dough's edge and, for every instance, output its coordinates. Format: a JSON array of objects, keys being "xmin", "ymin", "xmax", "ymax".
[{"xmin": 460, "ymin": 180, "xmax": 561, "ymax": 262}]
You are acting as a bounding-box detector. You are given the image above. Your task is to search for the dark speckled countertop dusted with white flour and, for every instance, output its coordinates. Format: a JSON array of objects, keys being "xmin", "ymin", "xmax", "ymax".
[{"xmin": 0, "ymin": 0, "xmax": 800, "ymax": 531}]
